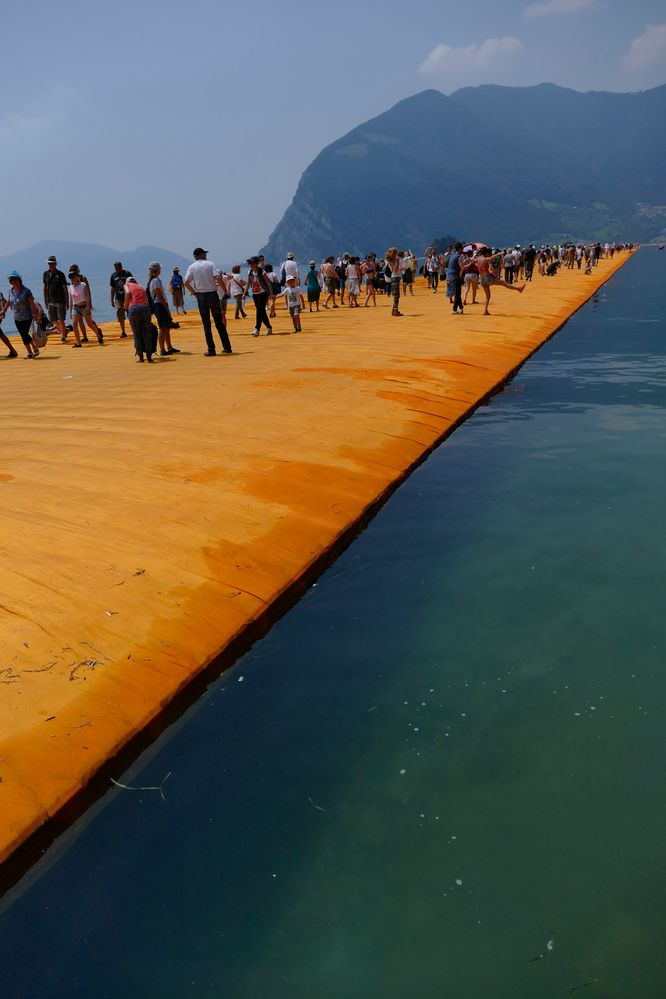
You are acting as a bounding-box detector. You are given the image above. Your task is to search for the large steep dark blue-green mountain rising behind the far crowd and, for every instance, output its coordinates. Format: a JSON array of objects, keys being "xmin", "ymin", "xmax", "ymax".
[{"xmin": 261, "ymin": 83, "xmax": 666, "ymax": 262}]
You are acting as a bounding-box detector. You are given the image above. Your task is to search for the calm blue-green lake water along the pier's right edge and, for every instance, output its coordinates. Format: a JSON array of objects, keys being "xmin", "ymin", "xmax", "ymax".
[{"xmin": 0, "ymin": 250, "xmax": 666, "ymax": 999}]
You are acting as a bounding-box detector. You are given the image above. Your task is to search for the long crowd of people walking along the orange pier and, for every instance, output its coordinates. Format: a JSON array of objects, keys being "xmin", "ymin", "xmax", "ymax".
[{"xmin": 0, "ymin": 242, "xmax": 633, "ymax": 363}]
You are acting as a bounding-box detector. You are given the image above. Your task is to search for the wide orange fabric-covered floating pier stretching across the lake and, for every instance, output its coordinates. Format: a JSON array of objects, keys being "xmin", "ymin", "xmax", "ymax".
[{"xmin": 0, "ymin": 254, "xmax": 627, "ymax": 869}]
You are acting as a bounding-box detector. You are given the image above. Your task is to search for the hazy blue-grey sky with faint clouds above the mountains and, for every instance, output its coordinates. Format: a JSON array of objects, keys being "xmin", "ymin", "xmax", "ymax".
[{"xmin": 0, "ymin": 0, "xmax": 666, "ymax": 263}]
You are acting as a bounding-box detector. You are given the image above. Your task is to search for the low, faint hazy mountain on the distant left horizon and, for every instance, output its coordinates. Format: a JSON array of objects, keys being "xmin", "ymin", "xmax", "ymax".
[{"xmin": 0, "ymin": 239, "xmax": 191, "ymax": 278}]
